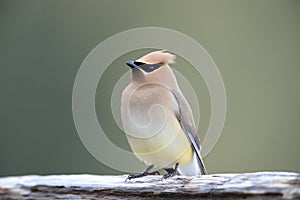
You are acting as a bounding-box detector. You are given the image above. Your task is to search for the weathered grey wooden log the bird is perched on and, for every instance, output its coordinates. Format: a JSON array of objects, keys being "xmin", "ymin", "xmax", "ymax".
[{"xmin": 0, "ymin": 172, "xmax": 300, "ymax": 199}]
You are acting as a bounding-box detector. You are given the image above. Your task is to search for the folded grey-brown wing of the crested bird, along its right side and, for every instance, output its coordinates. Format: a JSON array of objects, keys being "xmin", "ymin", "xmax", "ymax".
[{"xmin": 171, "ymin": 90, "xmax": 207, "ymax": 174}]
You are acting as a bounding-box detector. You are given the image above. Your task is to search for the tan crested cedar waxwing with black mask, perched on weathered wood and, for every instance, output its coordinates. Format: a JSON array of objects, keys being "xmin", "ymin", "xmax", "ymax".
[{"xmin": 121, "ymin": 51, "xmax": 206, "ymax": 180}]
